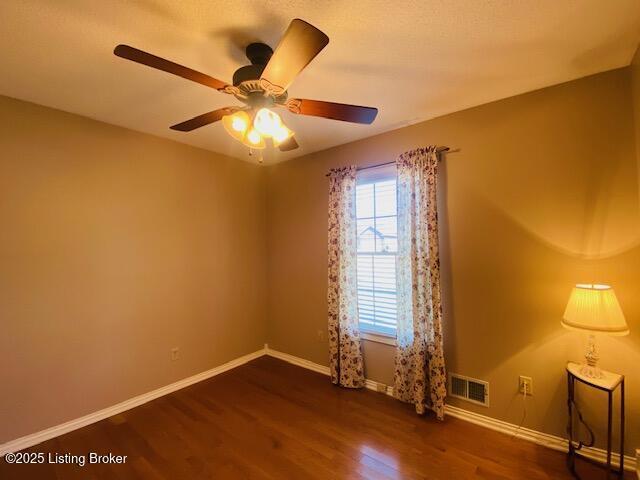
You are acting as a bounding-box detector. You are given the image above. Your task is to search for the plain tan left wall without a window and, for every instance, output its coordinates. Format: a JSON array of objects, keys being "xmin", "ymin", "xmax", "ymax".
[{"xmin": 0, "ymin": 97, "xmax": 266, "ymax": 443}]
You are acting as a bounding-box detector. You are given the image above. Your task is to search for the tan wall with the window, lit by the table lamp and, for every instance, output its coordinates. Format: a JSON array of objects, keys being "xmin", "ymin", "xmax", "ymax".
[{"xmin": 267, "ymin": 68, "xmax": 640, "ymax": 452}]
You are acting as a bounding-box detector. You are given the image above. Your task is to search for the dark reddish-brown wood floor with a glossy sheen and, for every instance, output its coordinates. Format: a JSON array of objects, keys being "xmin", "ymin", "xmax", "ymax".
[{"xmin": 0, "ymin": 357, "xmax": 631, "ymax": 480}]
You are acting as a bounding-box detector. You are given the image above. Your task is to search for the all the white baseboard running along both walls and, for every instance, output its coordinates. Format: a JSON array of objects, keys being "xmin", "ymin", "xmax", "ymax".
[{"xmin": 0, "ymin": 344, "xmax": 637, "ymax": 471}]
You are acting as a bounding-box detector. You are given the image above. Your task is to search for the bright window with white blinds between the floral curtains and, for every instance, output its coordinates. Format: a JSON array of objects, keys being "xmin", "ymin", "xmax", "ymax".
[{"xmin": 356, "ymin": 165, "xmax": 398, "ymax": 337}]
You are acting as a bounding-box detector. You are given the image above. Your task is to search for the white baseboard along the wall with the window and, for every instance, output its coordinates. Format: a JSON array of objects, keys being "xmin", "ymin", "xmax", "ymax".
[{"xmin": 265, "ymin": 345, "xmax": 637, "ymax": 471}]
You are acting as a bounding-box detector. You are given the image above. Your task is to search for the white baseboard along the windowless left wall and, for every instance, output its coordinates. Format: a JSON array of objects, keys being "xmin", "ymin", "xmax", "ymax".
[{"xmin": 0, "ymin": 348, "xmax": 265, "ymax": 457}]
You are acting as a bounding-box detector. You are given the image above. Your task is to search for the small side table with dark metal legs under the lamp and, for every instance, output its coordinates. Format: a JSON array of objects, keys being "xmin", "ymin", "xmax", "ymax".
[{"xmin": 567, "ymin": 362, "xmax": 624, "ymax": 478}]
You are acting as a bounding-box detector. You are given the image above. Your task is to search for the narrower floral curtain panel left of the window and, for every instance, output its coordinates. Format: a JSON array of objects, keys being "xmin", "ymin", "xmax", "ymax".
[{"xmin": 327, "ymin": 166, "xmax": 364, "ymax": 388}]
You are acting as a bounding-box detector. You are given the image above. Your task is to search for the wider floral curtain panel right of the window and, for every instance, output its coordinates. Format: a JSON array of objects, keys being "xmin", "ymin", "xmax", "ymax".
[{"xmin": 393, "ymin": 146, "xmax": 446, "ymax": 420}]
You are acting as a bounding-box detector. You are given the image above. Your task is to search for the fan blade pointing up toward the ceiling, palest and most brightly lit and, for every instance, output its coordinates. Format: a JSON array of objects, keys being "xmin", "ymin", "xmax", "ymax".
[{"xmin": 261, "ymin": 18, "xmax": 329, "ymax": 92}]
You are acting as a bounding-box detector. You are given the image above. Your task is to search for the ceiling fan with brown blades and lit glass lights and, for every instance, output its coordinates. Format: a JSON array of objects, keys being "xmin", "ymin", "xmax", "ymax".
[{"xmin": 113, "ymin": 18, "xmax": 378, "ymax": 152}]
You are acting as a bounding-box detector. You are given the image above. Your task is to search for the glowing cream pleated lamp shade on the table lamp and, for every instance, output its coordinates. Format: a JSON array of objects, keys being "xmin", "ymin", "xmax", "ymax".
[{"xmin": 562, "ymin": 283, "xmax": 629, "ymax": 335}]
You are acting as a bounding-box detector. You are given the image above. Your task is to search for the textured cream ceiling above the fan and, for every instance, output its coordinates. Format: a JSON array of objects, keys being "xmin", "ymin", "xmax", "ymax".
[{"xmin": 0, "ymin": 0, "xmax": 640, "ymax": 162}]
